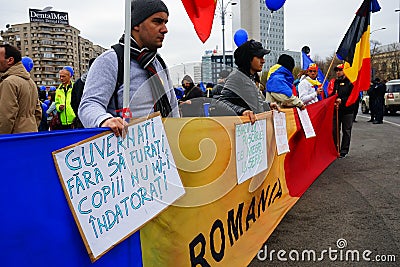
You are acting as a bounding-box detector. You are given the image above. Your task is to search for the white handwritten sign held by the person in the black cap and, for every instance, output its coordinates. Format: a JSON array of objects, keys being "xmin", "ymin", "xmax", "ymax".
[{"xmin": 235, "ymin": 120, "xmax": 268, "ymax": 184}]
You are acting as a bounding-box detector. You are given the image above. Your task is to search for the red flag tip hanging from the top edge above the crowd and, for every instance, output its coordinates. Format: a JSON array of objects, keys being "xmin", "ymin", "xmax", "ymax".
[{"xmin": 182, "ymin": 0, "xmax": 217, "ymax": 43}]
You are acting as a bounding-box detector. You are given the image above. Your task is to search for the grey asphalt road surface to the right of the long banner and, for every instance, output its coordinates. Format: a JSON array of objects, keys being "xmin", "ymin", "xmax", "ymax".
[{"xmin": 249, "ymin": 114, "xmax": 400, "ymax": 267}]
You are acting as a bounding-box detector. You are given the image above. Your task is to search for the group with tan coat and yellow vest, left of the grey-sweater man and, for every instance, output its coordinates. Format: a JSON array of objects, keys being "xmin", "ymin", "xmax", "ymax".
[{"xmin": 0, "ymin": 41, "xmax": 94, "ymax": 134}]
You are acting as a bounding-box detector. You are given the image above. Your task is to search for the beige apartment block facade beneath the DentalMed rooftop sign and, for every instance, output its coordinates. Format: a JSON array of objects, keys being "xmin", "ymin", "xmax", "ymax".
[{"xmin": 0, "ymin": 13, "xmax": 106, "ymax": 86}]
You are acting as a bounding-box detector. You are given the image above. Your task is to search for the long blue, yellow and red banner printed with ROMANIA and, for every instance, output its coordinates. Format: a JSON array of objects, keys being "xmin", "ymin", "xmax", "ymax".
[{"xmin": 0, "ymin": 97, "xmax": 337, "ymax": 267}]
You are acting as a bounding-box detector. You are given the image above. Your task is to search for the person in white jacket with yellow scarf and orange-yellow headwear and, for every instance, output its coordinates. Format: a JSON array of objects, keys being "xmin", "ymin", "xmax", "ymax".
[{"xmin": 298, "ymin": 63, "xmax": 323, "ymax": 105}]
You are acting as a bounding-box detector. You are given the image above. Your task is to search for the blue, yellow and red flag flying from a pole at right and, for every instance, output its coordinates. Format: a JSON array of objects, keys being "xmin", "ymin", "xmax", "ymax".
[{"xmin": 336, "ymin": 0, "xmax": 380, "ymax": 106}]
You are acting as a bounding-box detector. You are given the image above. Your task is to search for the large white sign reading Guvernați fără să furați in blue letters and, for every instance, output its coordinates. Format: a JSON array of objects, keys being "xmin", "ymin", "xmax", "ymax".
[{"xmin": 53, "ymin": 116, "xmax": 185, "ymax": 261}]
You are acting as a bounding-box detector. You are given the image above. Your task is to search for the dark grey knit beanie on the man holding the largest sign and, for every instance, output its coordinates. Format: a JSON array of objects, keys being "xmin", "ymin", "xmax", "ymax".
[{"xmin": 131, "ymin": 0, "xmax": 169, "ymax": 28}]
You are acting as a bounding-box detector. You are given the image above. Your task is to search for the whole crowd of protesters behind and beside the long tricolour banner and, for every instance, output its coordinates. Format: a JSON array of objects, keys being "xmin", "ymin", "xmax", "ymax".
[{"xmin": 0, "ymin": 0, "xmax": 384, "ymax": 157}]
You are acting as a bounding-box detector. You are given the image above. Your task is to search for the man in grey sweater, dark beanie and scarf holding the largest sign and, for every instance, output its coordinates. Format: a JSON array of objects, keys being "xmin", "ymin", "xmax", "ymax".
[{"xmin": 78, "ymin": 0, "xmax": 179, "ymax": 136}]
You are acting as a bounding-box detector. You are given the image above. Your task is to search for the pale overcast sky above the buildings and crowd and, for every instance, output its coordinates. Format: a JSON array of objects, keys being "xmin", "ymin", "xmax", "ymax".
[{"xmin": 0, "ymin": 0, "xmax": 400, "ymax": 67}]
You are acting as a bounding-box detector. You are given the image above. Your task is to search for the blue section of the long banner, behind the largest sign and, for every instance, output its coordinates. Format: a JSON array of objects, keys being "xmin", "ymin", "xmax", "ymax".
[{"xmin": 0, "ymin": 128, "xmax": 142, "ymax": 267}]
